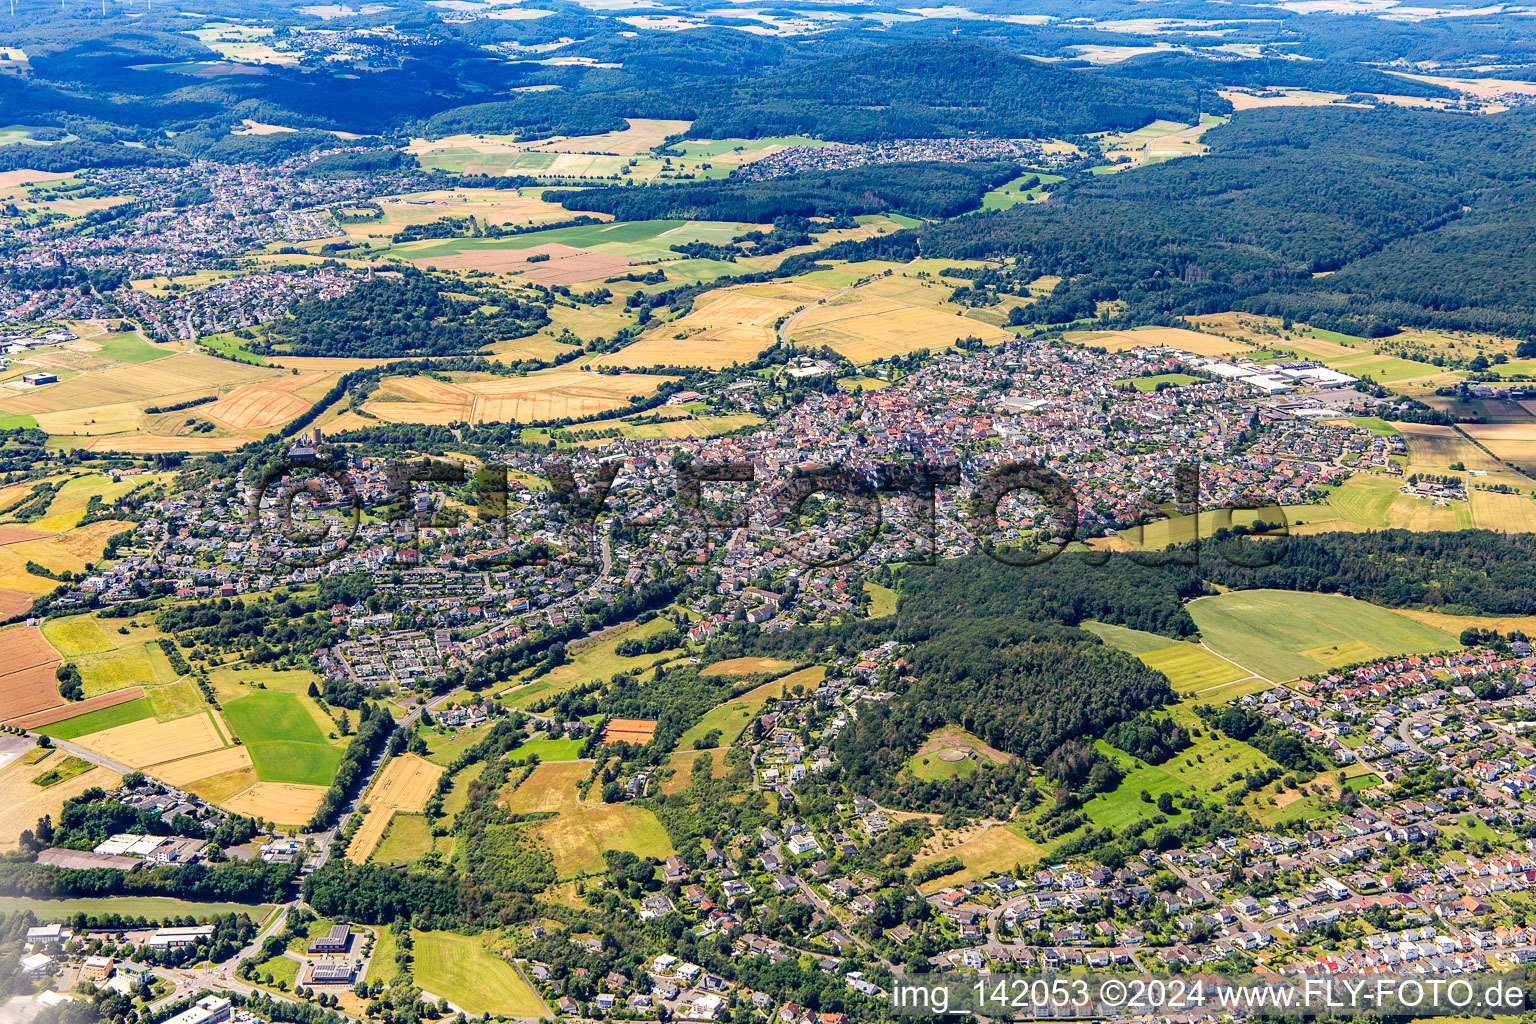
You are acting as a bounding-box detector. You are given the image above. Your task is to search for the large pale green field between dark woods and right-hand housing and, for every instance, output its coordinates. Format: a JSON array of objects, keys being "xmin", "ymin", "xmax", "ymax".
[{"xmin": 1189, "ymin": 590, "xmax": 1459, "ymax": 682}]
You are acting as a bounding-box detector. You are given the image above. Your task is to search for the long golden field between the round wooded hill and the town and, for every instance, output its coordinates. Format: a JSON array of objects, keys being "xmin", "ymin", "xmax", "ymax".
[{"xmin": 362, "ymin": 370, "xmax": 676, "ymax": 424}]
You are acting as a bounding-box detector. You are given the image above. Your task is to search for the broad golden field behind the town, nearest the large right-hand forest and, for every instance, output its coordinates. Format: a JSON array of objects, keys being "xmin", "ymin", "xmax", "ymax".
[{"xmin": 790, "ymin": 267, "xmax": 1014, "ymax": 364}]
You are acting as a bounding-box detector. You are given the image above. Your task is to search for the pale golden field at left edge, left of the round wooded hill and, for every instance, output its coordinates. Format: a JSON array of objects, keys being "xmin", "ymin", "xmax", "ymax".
[{"xmin": 0, "ymin": 353, "xmax": 276, "ymax": 417}]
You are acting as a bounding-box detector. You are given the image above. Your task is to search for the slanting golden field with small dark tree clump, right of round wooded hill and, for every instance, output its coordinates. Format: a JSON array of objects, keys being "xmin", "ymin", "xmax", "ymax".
[{"xmin": 593, "ymin": 284, "xmax": 811, "ymax": 370}]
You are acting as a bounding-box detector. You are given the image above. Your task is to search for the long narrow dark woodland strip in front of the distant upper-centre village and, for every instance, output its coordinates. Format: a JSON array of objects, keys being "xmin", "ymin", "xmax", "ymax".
[{"xmin": 545, "ymin": 161, "xmax": 1020, "ymax": 224}]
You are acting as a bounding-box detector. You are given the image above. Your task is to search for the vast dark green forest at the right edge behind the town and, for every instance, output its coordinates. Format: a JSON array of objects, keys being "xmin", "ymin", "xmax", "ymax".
[{"xmin": 922, "ymin": 107, "xmax": 1536, "ymax": 335}]
